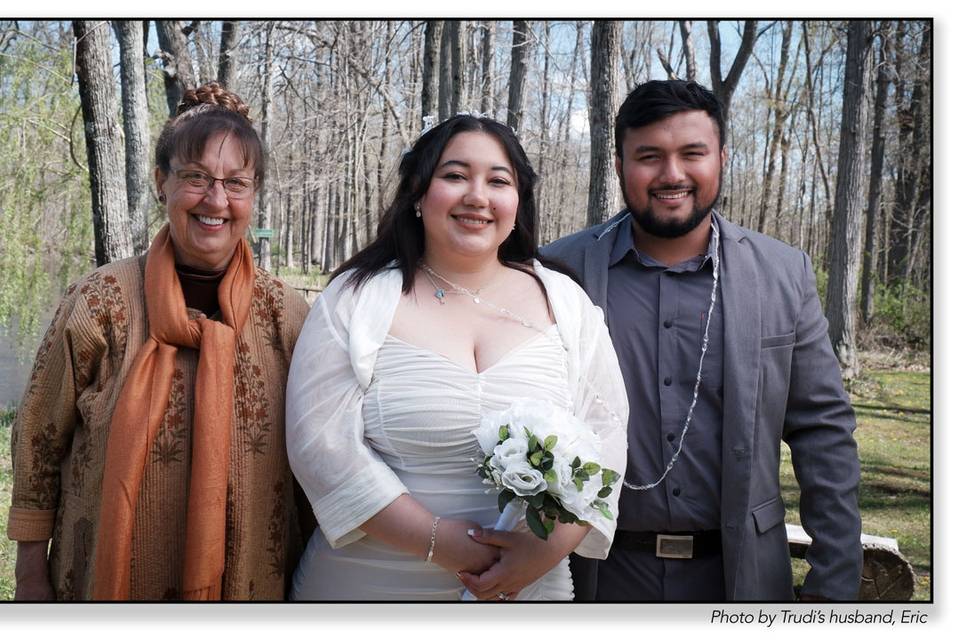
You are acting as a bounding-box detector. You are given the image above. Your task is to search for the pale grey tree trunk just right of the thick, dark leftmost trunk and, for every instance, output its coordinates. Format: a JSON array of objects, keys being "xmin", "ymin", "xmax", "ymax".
[{"xmin": 113, "ymin": 20, "xmax": 152, "ymax": 254}]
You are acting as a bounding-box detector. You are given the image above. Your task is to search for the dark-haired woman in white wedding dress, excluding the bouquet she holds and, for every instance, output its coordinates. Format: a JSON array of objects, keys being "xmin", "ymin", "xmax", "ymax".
[{"xmin": 287, "ymin": 115, "xmax": 627, "ymax": 601}]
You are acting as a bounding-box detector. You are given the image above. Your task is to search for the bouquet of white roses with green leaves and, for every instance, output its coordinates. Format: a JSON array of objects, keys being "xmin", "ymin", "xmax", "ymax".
[{"xmin": 473, "ymin": 399, "xmax": 620, "ymax": 540}]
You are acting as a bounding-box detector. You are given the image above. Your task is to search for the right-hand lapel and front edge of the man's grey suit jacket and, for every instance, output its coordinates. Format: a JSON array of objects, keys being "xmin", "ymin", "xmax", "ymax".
[{"xmin": 720, "ymin": 218, "xmax": 761, "ymax": 598}]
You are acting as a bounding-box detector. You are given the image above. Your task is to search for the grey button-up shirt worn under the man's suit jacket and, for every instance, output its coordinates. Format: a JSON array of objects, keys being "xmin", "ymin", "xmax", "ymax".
[{"xmin": 607, "ymin": 219, "xmax": 723, "ymax": 532}]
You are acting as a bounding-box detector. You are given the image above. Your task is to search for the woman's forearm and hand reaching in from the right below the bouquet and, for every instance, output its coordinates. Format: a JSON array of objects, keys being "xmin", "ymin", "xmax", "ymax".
[{"xmin": 460, "ymin": 525, "xmax": 589, "ymax": 600}]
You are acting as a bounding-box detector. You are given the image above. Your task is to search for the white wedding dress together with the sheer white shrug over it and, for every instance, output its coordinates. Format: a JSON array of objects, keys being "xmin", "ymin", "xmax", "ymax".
[{"xmin": 286, "ymin": 265, "xmax": 627, "ymax": 601}]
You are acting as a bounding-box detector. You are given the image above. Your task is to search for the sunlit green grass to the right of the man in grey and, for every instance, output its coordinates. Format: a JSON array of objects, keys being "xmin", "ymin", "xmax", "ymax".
[{"xmin": 780, "ymin": 370, "xmax": 932, "ymax": 600}]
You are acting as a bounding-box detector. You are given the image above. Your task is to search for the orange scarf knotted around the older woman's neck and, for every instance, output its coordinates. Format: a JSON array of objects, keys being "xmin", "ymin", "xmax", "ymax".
[{"xmin": 93, "ymin": 225, "xmax": 255, "ymax": 600}]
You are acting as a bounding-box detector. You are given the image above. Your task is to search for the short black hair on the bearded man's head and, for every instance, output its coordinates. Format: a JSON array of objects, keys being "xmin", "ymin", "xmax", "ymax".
[{"xmin": 614, "ymin": 80, "xmax": 727, "ymax": 160}]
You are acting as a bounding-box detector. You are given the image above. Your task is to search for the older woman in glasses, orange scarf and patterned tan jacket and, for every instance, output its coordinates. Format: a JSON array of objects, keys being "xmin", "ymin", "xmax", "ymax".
[{"xmin": 7, "ymin": 83, "xmax": 307, "ymax": 600}]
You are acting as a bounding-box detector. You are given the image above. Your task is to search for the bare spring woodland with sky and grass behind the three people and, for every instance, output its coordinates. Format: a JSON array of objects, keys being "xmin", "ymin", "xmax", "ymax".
[{"xmin": 0, "ymin": 19, "xmax": 933, "ymax": 597}]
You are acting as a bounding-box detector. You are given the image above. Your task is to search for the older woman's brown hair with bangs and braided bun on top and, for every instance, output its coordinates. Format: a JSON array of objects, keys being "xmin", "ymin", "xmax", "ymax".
[{"xmin": 155, "ymin": 82, "xmax": 265, "ymax": 184}]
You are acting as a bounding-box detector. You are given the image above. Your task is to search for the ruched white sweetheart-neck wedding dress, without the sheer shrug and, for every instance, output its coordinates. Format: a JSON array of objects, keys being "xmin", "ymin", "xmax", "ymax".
[{"xmin": 293, "ymin": 326, "xmax": 573, "ymax": 601}]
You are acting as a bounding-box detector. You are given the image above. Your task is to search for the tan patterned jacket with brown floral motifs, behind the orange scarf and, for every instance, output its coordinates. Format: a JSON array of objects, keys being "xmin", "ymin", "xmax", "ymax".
[{"xmin": 7, "ymin": 257, "xmax": 309, "ymax": 600}]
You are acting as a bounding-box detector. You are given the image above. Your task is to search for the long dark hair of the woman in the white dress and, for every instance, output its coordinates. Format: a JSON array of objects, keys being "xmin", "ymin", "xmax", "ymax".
[{"xmin": 331, "ymin": 115, "xmax": 539, "ymax": 293}]
